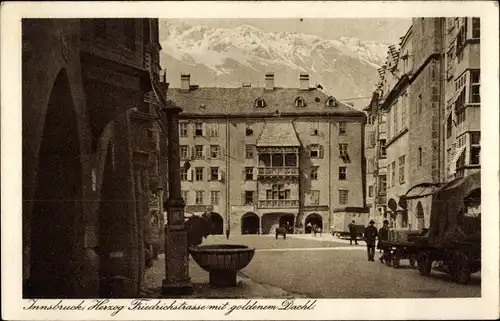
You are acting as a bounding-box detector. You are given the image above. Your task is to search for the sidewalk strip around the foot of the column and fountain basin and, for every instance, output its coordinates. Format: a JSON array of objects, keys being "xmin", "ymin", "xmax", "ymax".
[{"xmin": 141, "ymin": 254, "xmax": 305, "ymax": 299}]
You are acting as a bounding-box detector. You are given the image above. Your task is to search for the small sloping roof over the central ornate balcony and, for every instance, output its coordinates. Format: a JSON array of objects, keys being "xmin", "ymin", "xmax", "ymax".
[{"xmin": 257, "ymin": 122, "xmax": 300, "ymax": 147}]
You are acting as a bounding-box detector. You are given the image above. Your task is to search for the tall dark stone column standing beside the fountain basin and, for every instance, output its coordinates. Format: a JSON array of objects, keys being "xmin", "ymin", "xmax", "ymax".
[{"xmin": 162, "ymin": 106, "xmax": 193, "ymax": 295}]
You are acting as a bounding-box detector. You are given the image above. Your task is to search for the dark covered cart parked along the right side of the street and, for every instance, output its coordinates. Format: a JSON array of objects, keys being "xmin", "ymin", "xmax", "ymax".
[{"xmin": 381, "ymin": 172, "xmax": 481, "ymax": 283}]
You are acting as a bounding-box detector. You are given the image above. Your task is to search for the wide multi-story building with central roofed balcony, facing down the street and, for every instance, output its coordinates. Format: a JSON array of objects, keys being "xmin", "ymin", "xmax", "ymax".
[{"xmin": 168, "ymin": 73, "xmax": 364, "ymax": 234}]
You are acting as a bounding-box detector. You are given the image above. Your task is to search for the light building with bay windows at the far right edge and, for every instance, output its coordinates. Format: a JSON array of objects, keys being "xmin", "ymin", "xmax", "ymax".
[{"xmin": 443, "ymin": 17, "xmax": 481, "ymax": 180}]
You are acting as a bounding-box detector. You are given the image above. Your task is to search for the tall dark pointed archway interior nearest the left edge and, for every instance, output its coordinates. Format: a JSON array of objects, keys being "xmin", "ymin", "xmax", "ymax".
[{"xmin": 25, "ymin": 71, "xmax": 82, "ymax": 298}]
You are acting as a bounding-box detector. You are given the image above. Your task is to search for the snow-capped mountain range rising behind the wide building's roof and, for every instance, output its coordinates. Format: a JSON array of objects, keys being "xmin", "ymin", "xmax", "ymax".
[{"xmin": 160, "ymin": 20, "xmax": 388, "ymax": 107}]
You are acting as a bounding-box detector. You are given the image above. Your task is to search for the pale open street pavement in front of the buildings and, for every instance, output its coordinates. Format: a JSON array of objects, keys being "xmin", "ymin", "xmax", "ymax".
[{"xmin": 203, "ymin": 234, "xmax": 481, "ymax": 298}]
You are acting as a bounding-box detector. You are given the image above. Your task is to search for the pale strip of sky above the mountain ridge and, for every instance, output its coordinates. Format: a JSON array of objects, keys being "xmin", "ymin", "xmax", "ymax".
[{"xmin": 169, "ymin": 18, "xmax": 411, "ymax": 44}]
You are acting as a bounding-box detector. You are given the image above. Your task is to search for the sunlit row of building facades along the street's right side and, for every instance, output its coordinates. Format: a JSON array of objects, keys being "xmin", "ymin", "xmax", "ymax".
[{"xmin": 367, "ymin": 17, "xmax": 480, "ymax": 229}]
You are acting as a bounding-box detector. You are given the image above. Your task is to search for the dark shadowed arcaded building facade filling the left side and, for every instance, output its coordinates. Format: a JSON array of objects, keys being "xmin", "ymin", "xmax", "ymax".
[{"xmin": 22, "ymin": 19, "xmax": 166, "ymax": 298}]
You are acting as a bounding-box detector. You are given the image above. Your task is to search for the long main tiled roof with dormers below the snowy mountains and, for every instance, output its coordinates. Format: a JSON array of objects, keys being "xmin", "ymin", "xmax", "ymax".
[{"xmin": 167, "ymin": 87, "xmax": 363, "ymax": 116}]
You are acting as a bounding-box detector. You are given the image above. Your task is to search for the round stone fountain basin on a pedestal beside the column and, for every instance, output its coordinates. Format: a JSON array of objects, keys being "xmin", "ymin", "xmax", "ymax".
[{"xmin": 189, "ymin": 244, "xmax": 255, "ymax": 287}]
